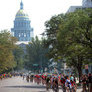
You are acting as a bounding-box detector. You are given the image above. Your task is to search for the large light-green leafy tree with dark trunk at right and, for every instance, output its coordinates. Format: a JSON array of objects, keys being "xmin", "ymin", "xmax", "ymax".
[{"xmin": 58, "ymin": 10, "xmax": 92, "ymax": 79}]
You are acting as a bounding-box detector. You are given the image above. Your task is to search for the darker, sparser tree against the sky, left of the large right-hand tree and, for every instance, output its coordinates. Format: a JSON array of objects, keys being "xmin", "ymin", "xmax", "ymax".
[{"xmin": 44, "ymin": 14, "xmax": 64, "ymax": 59}]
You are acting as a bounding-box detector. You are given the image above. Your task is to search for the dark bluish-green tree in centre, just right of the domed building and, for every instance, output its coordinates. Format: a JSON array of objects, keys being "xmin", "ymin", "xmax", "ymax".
[{"xmin": 25, "ymin": 37, "xmax": 49, "ymax": 71}]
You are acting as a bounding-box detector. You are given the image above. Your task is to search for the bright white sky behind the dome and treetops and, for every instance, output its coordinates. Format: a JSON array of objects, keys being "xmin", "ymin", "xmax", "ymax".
[{"xmin": 0, "ymin": 0, "xmax": 82, "ymax": 37}]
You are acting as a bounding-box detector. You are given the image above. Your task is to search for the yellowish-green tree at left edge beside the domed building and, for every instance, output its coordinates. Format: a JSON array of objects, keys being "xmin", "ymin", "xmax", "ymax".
[{"xmin": 0, "ymin": 30, "xmax": 16, "ymax": 73}]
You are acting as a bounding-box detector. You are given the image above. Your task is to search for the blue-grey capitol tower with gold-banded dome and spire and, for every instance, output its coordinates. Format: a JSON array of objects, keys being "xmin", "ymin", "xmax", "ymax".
[{"xmin": 11, "ymin": 0, "xmax": 33, "ymax": 42}]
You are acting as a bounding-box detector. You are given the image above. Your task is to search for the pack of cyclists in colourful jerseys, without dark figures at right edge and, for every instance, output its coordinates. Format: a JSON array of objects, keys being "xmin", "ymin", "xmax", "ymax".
[{"xmin": 23, "ymin": 74, "xmax": 77, "ymax": 92}]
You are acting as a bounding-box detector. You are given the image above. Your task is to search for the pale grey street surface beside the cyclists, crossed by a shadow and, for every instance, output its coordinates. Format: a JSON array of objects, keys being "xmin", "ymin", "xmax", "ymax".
[{"xmin": 0, "ymin": 77, "xmax": 81, "ymax": 92}]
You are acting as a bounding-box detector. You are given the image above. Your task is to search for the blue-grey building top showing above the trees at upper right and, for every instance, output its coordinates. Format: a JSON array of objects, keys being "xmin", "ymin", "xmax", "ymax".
[{"xmin": 67, "ymin": 0, "xmax": 92, "ymax": 13}]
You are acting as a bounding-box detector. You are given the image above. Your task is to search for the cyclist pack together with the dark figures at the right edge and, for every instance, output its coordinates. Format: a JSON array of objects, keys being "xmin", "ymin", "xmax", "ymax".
[{"xmin": 23, "ymin": 74, "xmax": 92, "ymax": 92}]
